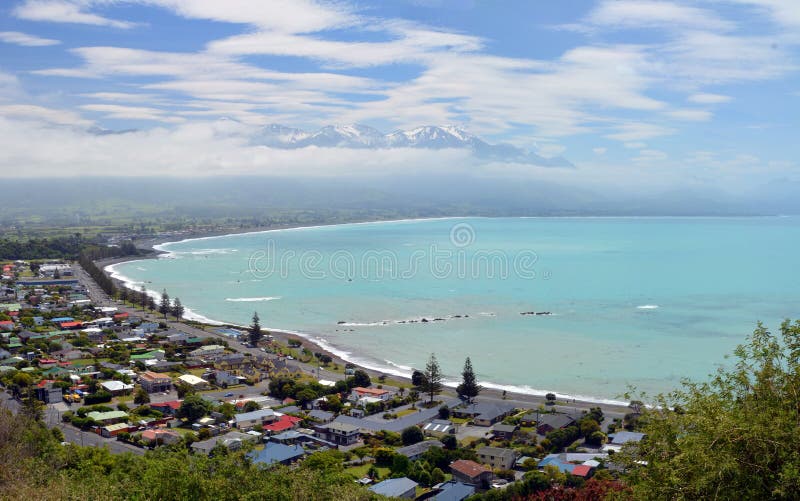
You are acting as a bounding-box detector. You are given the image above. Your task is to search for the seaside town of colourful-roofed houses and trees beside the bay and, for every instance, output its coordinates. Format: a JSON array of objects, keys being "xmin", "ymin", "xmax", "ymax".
[{"xmin": 0, "ymin": 261, "xmax": 644, "ymax": 500}]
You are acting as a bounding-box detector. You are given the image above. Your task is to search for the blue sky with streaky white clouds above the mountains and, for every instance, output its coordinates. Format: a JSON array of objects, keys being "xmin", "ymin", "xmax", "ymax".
[{"xmin": 0, "ymin": 0, "xmax": 800, "ymax": 193}]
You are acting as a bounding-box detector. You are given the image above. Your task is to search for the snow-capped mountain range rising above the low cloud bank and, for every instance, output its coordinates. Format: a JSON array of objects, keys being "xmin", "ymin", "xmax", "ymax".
[{"xmin": 252, "ymin": 124, "xmax": 573, "ymax": 167}]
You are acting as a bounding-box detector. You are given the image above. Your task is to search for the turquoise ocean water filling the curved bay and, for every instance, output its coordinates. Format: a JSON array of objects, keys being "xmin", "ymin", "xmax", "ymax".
[{"xmin": 110, "ymin": 217, "xmax": 800, "ymax": 401}]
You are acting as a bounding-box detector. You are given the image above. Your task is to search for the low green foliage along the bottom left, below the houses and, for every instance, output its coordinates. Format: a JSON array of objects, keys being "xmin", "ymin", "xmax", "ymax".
[{"xmin": 0, "ymin": 410, "xmax": 373, "ymax": 501}]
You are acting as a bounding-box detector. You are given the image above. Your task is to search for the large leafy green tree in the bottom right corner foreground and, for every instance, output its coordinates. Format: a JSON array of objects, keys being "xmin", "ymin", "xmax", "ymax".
[{"xmin": 614, "ymin": 321, "xmax": 800, "ymax": 499}]
